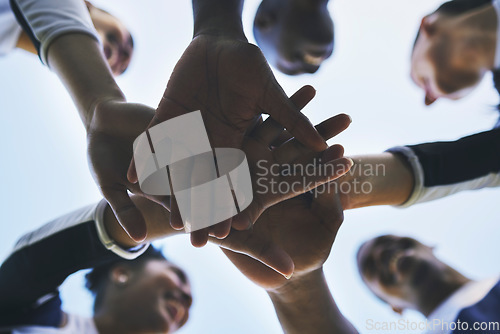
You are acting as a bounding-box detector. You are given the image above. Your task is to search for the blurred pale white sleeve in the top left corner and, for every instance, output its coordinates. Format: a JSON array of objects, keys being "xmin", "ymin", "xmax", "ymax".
[{"xmin": 0, "ymin": 0, "xmax": 22, "ymax": 56}]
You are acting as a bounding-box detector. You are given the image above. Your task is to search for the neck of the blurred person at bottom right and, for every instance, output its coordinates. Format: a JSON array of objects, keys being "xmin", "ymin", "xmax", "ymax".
[{"xmin": 417, "ymin": 266, "xmax": 471, "ymax": 317}]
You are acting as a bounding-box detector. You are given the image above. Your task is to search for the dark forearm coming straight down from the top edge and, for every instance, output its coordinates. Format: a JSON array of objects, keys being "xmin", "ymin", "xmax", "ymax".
[{"xmin": 193, "ymin": 0, "xmax": 246, "ymax": 41}]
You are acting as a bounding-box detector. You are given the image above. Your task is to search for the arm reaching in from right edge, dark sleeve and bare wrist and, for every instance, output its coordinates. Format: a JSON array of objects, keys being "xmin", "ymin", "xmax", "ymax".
[{"xmin": 334, "ymin": 128, "xmax": 500, "ymax": 210}]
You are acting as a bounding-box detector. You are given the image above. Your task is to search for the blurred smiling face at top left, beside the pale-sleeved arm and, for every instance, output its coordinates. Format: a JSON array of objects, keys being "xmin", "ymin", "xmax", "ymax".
[{"xmin": 86, "ymin": 2, "xmax": 134, "ymax": 76}]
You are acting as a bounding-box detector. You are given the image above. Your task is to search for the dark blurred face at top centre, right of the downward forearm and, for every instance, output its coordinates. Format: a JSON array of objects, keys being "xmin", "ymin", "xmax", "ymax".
[{"xmin": 254, "ymin": 0, "xmax": 333, "ymax": 75}]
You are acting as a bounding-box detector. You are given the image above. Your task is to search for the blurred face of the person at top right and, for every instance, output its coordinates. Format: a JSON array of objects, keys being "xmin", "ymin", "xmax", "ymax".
[{"xmin": 411, "ymin": 13, "xmax": 486, "ymax": 105}]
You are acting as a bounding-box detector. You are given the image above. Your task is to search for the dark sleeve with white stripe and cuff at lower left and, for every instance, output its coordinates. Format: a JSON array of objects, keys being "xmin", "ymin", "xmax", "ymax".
[{"xmin": 0, "ymin": 201, "xmax": 146, "ymax": 329}]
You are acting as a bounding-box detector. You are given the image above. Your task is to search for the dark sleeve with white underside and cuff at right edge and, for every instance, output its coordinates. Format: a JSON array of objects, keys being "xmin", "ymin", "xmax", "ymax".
[{"xmin": 388, "ymin": 128, "xmax": 500, "ymax": 207}]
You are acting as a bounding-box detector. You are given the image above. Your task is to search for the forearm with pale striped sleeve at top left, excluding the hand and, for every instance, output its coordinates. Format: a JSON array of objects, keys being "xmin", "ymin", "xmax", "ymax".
[{"xmin": 11, "ymin": 0, "xmax": 124, "ymax": 128}]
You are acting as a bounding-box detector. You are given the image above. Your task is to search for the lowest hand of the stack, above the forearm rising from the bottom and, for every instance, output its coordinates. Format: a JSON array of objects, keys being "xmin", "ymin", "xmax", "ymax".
[{"xmin": 219, "ymin": 180, "xmax": 343, "ymax": 290}]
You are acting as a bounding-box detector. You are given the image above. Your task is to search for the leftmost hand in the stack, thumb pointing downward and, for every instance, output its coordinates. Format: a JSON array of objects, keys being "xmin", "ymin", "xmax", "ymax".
[{"xmin": 87, "ymin": 100, "xmax": 154, "ymax": 242}]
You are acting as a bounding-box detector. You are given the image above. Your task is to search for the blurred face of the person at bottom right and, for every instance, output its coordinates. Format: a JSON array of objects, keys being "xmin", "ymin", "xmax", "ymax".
[{"xmin": 357, "ymin": 235, "xmax": 443, "ymax": 313}]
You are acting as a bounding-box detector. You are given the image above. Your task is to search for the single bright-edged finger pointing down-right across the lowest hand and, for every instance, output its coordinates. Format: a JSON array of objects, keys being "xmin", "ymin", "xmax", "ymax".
[{"xmin": 211, "ymin": 231, "xmax": 294, "ymax": 279}]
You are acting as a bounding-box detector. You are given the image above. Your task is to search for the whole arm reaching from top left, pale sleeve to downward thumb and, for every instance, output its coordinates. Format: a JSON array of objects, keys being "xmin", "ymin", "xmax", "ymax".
[{"xmin": 11, "ymin": 0, "xmax": 152, "ymax": 240}]
